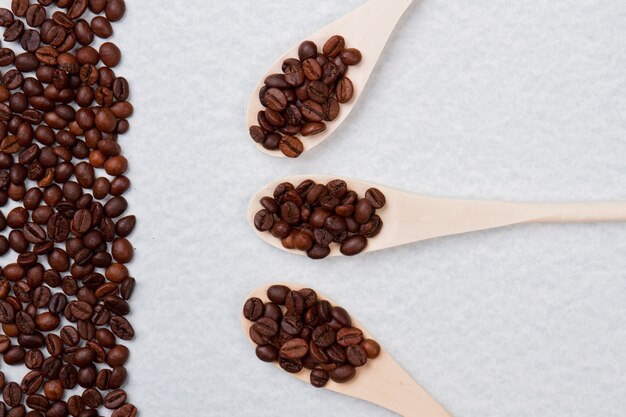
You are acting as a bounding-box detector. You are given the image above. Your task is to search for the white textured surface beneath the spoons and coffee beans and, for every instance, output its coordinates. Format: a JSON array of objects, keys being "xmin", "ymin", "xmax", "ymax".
[{"xmin": 123, "ymin": 0, "xmax": 626, "ymax": 417}]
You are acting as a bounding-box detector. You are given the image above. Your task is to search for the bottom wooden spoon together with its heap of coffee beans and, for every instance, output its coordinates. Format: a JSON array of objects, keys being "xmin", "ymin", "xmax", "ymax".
[{"xmin": 241, "ymin": 283, "xmax": 450, "ymax": 417}]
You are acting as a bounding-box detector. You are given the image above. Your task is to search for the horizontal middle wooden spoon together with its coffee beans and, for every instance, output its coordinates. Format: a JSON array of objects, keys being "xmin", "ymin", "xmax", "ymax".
[{"xmin": 247, "ymin": 175, "xmax": 626, "ymax": 259}]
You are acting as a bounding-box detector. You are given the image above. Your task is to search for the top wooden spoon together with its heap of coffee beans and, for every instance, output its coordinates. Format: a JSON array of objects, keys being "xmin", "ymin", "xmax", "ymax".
[{"xmin": 246, "ymin": 0, "xmax": 413, "ymax": 158}]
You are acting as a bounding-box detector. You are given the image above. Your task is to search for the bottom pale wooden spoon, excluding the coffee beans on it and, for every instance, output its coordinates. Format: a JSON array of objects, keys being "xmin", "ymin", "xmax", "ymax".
[{"xmin": 241, "ymin": 283, "xmax": 450, "ymax": 417}]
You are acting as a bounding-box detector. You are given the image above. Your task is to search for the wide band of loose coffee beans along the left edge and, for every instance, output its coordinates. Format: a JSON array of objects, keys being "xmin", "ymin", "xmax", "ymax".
[{"xmin": 0, "ymin": 0, "xmax": 137, "ymax": 417}]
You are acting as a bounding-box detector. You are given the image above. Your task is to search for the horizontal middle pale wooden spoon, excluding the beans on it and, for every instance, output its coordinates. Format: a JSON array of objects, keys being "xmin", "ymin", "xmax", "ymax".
[{"xmin": 248, "ymin": 175, "xmax": 626, "ymax": 256}]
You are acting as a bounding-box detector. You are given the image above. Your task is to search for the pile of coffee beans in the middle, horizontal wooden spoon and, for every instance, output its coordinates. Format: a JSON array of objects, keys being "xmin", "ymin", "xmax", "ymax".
[{"xmin": 254, "ymin": 179, "xmax": 386, "ymax": 259}]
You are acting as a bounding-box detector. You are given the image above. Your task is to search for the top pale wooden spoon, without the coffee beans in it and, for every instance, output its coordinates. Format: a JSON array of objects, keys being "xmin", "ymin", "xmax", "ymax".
[{"xmin": 246, "ymin": 0, "xmax": 413, "ymax": 157}]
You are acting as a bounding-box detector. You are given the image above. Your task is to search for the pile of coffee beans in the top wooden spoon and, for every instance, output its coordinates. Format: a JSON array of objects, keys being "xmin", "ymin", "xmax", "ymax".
[{"xmin": 250, "ymin": 35, "xmax": 362, "ymax": 158}]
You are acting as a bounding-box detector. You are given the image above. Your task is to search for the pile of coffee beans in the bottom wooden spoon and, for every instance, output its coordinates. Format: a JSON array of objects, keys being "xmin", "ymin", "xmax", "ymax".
[{"xmin": 243, "ymin": 285, "xmax": 380, "ymax": 388}]
